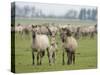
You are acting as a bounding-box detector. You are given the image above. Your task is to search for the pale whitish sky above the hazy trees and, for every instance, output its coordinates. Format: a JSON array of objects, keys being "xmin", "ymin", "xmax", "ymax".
[{"xmin": 16, "ymin": 2, "xmax": 96, "ymax": 16}]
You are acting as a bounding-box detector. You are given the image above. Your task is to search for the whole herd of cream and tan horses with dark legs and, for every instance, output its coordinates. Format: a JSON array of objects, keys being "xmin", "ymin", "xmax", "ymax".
[{"xmin": 11, "ymin": 23, "xmax": 97, "ymax": 65}]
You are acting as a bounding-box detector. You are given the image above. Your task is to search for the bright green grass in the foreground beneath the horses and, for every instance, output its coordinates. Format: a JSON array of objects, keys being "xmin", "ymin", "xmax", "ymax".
[{"xmin": 15, "ymin": 33, "xmax": 97, "ymax": 73}]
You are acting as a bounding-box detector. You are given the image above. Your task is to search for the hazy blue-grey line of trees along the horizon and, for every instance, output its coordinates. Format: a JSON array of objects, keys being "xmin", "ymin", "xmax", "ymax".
[{"xmin": 11, "ymin": 5, "xmax": 97, "ymax": 20}]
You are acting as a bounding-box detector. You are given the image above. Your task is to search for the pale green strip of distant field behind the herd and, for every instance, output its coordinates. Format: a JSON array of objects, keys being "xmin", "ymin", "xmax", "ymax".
[{"xmin": 15, "ymin": 18, "xmax": 97, "ymax": 25}]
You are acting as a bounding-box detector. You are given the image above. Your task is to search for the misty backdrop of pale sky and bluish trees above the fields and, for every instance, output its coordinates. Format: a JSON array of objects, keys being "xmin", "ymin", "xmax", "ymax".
[{"xmin": 11, "ymin": 2, "xmax": 97, "ymax": 21}]
